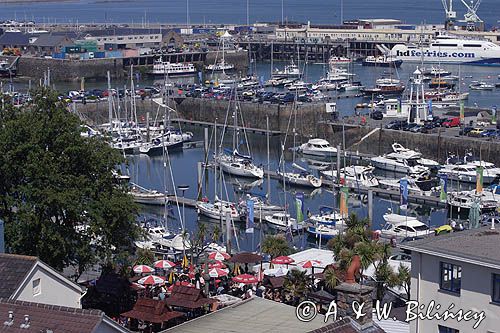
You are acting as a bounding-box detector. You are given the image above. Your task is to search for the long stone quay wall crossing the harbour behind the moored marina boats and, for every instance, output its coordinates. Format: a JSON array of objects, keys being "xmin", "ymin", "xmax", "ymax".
[{"xmin": 75, "ymin": 98, "xmax": 500, "ymax": 165}]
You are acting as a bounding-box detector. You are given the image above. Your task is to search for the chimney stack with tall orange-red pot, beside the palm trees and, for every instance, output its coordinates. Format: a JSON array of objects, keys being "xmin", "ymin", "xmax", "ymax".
[{"xmin": 335, "ymin": 255, "xmax": 374, "ymax": 330}]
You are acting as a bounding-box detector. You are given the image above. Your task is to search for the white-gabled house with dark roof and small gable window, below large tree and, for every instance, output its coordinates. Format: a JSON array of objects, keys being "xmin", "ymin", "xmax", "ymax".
[{"xmin": 0, "ymin": 254, "xmax": 83, "ymax": 308}]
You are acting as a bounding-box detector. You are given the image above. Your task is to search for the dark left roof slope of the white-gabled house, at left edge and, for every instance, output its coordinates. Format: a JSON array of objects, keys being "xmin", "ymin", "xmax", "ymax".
[{"xmin": 0, "ymin": 253, "xmax": 37, "ymax": 298}]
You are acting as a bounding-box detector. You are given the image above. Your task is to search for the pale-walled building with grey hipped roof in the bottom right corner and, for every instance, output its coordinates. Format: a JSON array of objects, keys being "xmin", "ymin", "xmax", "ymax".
[{"xmin": 401, "ymin": 227, "xmax": 500, "ymax": 333}]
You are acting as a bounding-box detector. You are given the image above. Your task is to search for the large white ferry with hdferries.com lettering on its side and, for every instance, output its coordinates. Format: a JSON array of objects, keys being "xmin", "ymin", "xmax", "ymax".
[{"xmin": 390, "ymin": 35, "xmax": 500, "ymax": 66}]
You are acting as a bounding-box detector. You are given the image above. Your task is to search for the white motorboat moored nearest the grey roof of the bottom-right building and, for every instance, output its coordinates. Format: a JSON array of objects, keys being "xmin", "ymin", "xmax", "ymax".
[{"xmin": 381, "ymin": 211, "xmax": 431, "ymax": 238}]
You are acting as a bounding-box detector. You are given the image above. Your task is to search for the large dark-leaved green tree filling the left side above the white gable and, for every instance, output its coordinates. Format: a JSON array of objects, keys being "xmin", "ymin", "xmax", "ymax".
[{"xmin": 0, "ymin": 90, "xmax": 140, "ymax": 278}]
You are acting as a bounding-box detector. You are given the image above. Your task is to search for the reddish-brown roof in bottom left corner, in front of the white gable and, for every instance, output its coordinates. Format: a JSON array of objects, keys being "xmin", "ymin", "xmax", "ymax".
[{"xmin": 0, "ymin": 299, "xmax": 119, "ymax": 333}]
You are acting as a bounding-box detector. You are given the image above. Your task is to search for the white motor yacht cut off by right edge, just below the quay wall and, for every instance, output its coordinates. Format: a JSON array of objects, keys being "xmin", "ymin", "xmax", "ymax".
[{"xmin": 439, "ymin": 161, "xmax": 500, "ymax": 184}]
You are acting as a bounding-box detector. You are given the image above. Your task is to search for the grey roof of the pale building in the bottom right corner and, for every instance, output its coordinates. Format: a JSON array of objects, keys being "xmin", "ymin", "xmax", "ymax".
[{"xmin": 401, "ymin": 227, "xmax": 500, "ymax": 267}]
